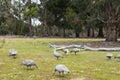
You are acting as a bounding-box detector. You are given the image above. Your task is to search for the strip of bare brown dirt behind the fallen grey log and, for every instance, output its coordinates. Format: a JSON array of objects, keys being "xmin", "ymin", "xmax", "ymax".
[{"xmin": 52, "ymin": 41, "xmax": 120, "ymax": 48}]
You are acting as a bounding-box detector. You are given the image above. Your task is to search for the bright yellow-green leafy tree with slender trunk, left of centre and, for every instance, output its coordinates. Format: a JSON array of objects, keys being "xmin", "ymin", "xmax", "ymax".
[{"xmin": 22, "ymin": 0, "xmax": 38, "ymax": 36}]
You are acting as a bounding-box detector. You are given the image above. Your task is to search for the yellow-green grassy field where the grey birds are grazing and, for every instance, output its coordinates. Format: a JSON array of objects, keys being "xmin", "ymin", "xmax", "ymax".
[{"xmin": 0, "ymin": 38, "xmax": 120, "ymax": 80}]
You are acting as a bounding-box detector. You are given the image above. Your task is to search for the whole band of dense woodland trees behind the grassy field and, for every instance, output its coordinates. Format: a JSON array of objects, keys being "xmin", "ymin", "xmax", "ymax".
[{"xmin": 0, "ymin": 0, "xmax": 120, "ymax": 41}]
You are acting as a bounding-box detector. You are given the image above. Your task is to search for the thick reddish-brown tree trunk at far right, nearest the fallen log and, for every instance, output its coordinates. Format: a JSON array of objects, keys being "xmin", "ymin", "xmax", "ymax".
[{"xmin": 106, "ymin": 1, "xmax": 119, "ymax": 42}]
